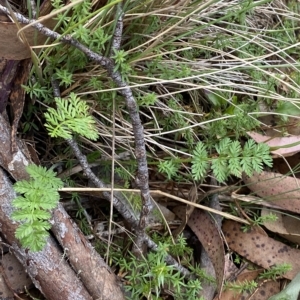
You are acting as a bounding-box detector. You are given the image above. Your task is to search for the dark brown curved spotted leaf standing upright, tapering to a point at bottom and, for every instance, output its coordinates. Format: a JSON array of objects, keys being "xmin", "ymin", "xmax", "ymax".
[{"xmin": 174, "ymin": 206, "xmax": 225, "ymax": 294}]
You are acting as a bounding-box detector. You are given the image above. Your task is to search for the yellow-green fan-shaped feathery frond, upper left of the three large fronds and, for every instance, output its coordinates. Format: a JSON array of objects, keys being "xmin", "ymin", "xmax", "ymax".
[{"xmin": 45, "ymin": 93, "xmax": 98, "ymax": 140}]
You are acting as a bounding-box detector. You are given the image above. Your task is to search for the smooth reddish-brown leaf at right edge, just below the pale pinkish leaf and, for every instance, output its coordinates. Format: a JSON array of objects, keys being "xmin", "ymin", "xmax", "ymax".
[{"xmin": 243, "ymin": 172, "xmax": 300, "ymax": 213}]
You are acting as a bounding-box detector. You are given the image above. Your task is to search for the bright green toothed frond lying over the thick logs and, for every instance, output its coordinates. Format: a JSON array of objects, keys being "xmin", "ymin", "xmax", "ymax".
[{"xmin": 12, "ymin": 164, "xmax": 63, "ymax": 251}]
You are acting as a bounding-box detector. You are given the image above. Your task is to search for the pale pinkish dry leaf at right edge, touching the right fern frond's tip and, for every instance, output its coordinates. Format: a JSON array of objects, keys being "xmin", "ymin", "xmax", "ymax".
[{"xmin": 247, "ymin": 131, "xmax": 300, "ymax": 158}]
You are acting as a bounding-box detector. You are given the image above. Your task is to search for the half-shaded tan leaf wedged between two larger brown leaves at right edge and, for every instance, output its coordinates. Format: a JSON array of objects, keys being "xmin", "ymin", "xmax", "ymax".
[{"xmin": 261, "ymin": 208, "xmax": 300, "ymax": 244}]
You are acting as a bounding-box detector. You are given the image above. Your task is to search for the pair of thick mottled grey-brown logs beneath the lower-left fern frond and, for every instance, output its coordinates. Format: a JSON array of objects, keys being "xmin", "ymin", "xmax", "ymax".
[{"xmin": 0, "ymin": 114, "xmax": 124, "ymax": 300}]
